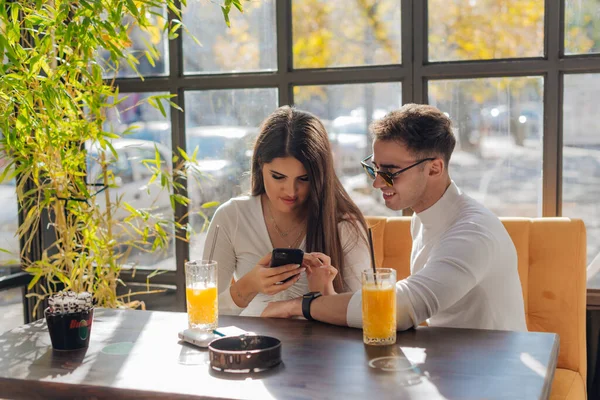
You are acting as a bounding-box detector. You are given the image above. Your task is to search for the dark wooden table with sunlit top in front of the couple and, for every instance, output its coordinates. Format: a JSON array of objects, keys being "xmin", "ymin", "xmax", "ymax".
[{"xmin": 0, "ymin": 309, "xmax": 558, "ymax": 400}]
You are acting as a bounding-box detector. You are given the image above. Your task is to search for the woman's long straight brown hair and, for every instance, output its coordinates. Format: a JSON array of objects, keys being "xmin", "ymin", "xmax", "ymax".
[{"xmin": 251, "ymin": 106, "xmax": 367, "ymax": 293}]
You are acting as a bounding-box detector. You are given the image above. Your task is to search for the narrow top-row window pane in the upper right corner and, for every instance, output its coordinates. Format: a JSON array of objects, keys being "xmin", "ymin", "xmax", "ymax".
[{"xmin": 565, "ymin": 0, "xmax": 600, "ymax": 54}]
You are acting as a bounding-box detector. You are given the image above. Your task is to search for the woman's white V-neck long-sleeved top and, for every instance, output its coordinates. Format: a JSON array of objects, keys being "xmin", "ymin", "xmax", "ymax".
[{"xmin": 203, "ymin": 196, "xmax": 370, "ymax": 316}]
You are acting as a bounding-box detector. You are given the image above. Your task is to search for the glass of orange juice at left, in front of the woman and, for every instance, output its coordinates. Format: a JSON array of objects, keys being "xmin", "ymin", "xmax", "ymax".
[{"xmin": 185, "ymin": 260, "xmax": 219, "ymax": 331}]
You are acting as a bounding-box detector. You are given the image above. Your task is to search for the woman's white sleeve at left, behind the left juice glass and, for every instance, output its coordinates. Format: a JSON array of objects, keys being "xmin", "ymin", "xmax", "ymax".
[{"xmin": 203, "ymin": 201, "xmax": 243, "ymax": 315}]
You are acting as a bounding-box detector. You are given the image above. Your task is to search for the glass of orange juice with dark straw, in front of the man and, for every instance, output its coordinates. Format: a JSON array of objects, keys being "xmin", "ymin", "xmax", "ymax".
[{"xmin": 362, "ymin": 268, "xmax": 396, "ymax": 346}]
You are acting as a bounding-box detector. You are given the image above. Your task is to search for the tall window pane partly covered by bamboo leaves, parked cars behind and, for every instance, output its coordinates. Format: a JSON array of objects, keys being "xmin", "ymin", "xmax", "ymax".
[{"xmin": 100, "ymin": 93, "xmax": 175, "ymax": 269}]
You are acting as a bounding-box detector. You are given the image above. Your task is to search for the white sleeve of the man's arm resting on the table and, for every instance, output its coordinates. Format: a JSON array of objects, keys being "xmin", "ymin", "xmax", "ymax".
[{"xmin": 346, "ymin": 223, "xmax": 494, "ymax": 331}]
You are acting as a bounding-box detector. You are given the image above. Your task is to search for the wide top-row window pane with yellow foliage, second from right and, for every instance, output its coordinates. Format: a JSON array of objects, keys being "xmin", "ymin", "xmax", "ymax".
[{"xmin": 428, "ymin": 0, "xmax": 544, "ymax": 61}]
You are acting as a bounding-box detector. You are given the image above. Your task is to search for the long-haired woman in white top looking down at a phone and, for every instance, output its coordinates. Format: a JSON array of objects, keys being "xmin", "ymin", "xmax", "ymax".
[{"xmin": 204, "ymin": 106, "xmax": 370, "ymax": 316}]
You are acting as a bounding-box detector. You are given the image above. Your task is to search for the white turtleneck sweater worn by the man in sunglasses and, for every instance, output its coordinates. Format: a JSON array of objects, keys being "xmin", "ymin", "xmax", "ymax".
[{"xmin": 346, "ymin": 182, "xmax": 527, "ymax": 331}]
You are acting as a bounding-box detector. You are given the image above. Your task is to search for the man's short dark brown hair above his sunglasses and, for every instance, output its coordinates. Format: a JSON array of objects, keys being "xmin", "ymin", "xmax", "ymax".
[{"xmin": 371, "ymin": 104, "xmax": 456, "ymax": 169}]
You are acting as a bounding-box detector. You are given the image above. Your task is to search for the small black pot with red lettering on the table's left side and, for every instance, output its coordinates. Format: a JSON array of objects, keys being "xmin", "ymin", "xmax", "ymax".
[{"xmin": 44, "ymin": 308, "xmax": 94, "ymax": 350}]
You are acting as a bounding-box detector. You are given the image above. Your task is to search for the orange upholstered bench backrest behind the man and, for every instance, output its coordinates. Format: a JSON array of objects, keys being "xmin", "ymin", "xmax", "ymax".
[{"xmin": 367, "ymin": 217, "xmax": 586, "ymax": 381}]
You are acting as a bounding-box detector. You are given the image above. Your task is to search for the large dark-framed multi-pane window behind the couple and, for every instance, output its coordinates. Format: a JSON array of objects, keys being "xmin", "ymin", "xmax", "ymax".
[{"xmin": 35, "ymin": 0, "xmax": 600, "ymax": 307}]
